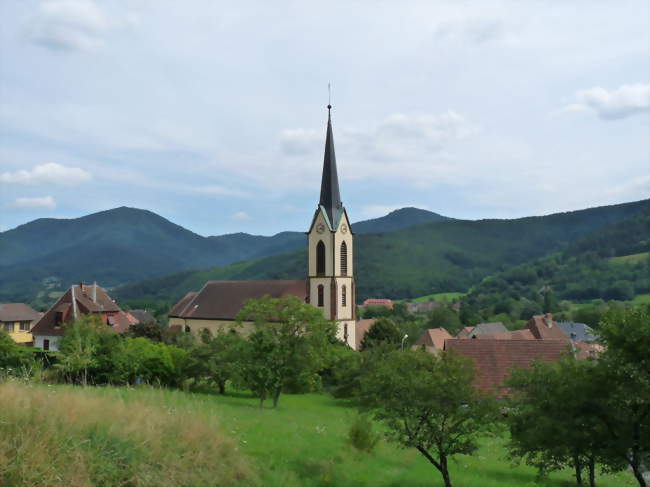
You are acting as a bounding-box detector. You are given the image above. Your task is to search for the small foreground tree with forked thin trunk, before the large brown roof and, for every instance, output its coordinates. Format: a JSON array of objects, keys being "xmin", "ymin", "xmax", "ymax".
[{"xmin": 361, "ymin": 350, "xmax": 494, "ymax": 487}]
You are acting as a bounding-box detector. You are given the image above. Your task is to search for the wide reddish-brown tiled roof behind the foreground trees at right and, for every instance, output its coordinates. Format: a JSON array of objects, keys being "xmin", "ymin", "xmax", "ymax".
[{"xmin": 445, "ymin": 339, "xmax": 570, "ymax": 397}]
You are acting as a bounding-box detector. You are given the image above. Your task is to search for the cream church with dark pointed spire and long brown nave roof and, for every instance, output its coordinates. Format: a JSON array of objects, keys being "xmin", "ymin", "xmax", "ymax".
[{"xmin": 169, "ymin": 105, "xmax": 356, "ymax": 348}]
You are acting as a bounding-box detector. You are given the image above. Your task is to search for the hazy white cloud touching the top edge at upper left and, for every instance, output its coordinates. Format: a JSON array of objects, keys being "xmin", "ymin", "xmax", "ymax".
[{"xmin": 28, "ymin": 0, "xmax": 109, "ymax": 51}]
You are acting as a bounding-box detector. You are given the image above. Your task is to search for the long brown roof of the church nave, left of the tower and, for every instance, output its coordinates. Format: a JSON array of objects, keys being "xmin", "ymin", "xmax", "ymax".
[{"xmin": 169, "ymin": 280, "xmax": 307, "ymax": 320}]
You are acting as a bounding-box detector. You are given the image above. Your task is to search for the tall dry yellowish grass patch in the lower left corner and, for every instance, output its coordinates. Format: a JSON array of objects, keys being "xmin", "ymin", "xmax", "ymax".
[{"xmin": 0, "ymin": 382, "xmax": 253, "ymax": 487}]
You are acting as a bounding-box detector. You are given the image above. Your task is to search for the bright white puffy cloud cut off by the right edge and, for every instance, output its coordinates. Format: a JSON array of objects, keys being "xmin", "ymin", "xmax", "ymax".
[{"xmin": 567, "ymin": 83, "xmax": 650, "ymax": 120}]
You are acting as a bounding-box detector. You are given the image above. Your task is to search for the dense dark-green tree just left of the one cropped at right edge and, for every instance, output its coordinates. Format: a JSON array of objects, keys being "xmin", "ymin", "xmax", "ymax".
[{"xmin": 508, "ymin": 357, "xmax": 621, "ymax": 487}]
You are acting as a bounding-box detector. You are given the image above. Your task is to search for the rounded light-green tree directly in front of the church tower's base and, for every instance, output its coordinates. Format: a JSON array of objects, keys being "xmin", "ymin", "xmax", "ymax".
[{"xmin": 237, "ymin": 296, "xmax": 336, "ymax": 407}]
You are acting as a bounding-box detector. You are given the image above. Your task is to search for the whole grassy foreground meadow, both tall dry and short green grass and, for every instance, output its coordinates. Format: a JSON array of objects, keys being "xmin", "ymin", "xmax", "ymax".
[{"xmin": 0, "ymin": 384, "xmax": 635, "ymax": 487}]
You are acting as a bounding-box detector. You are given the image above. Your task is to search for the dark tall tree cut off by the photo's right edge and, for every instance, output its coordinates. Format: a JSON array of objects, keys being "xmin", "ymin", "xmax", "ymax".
[{"xmin": 593, "ymin": 306, "xmax": 650, "ymax": 487}]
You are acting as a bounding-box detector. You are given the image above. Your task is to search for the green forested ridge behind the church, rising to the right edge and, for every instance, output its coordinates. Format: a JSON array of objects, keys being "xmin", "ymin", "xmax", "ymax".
[{"xmin": 115, "ymin": 200, "xmax": 650, "ymax": 301}]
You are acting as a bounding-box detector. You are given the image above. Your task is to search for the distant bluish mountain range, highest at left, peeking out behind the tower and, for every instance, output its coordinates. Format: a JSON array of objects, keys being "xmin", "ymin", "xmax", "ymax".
[{"xmin": 0, "ymin": 203, "xmax": 444, "ymax": 302}]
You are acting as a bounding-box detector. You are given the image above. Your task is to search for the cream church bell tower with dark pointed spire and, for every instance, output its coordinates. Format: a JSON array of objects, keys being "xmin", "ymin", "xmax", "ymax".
[{"xmin": 307, "ymin": 105, "xmax": 356, "ymax": 348}]
